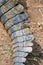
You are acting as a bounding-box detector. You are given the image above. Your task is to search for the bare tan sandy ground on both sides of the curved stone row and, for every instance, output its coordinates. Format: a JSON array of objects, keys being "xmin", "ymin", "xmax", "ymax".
[{"xmin": 0, "ymin": 0, "xmax": 43, "ymax": 65}]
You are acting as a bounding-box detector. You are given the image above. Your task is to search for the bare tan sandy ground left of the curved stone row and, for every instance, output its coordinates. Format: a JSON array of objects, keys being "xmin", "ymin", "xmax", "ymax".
[{"xmin": 0, "ymin": 23, "xmax": 13, "ymax": 65}]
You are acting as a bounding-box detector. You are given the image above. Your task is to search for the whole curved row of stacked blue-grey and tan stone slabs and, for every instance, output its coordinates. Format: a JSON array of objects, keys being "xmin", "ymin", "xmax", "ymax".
[{"xmin": 0, "ymin": 0, "xmax": 34, "ymax": 65}]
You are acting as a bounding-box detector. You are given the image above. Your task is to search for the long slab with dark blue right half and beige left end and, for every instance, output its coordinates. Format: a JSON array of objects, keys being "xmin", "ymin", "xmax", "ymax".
[{"xmin": 2, "ymin": 12, "xmax": 28, "ymax": 28}]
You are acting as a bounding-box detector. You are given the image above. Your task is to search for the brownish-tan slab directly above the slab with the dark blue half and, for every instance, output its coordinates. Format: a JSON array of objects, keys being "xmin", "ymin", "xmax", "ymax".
[{"xmin": 1, "ymin": 4, "xmax": 24, "ymax": 21}]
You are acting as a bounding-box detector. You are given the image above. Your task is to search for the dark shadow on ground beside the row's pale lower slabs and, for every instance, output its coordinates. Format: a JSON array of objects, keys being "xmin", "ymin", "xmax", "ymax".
[{"xmin": 25, "ymin": 41, "xmax": 43, "ymax": 65}]
